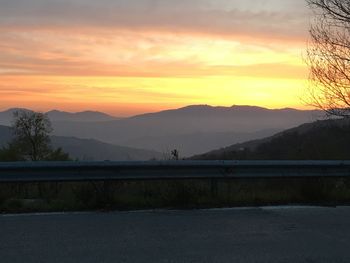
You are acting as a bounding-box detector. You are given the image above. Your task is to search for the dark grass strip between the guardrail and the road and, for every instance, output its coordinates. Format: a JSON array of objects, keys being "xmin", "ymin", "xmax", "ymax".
[{"xmin": 0, "ymin": 178, "xmax": 350, "ymax": 213}]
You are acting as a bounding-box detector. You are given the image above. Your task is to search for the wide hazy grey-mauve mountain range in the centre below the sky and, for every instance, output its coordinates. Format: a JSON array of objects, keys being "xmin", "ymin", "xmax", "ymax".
[{"xmin": 0, "ymin": 105, "xmax": 323, "ymax": 157}]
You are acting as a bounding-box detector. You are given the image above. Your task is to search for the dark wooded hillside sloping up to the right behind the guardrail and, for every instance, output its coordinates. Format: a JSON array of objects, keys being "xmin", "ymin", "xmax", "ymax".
[{"xmin": 190, "ymin": 119, "xmax": 350, "ymax": 160}]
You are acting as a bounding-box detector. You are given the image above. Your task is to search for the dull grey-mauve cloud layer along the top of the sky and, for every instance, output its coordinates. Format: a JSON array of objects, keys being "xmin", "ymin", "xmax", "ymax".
[{"xmin": 0, "ymin": 0, "xmax": 307, "ymax": 39}]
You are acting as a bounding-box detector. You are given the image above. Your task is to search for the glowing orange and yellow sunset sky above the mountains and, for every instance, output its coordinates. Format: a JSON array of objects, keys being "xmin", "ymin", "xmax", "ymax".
[{"xmin": 0, "ymin": 0, "xmax": 310, "ymax": 116}]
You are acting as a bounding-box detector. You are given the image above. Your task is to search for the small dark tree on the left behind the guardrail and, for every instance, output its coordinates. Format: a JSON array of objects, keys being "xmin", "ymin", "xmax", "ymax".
[{"xmin": 12, "ymin": 111, "xmax": 52, "ymax": 161}]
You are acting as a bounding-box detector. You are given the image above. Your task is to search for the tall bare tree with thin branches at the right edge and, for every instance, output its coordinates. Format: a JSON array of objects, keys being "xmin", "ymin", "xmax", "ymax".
[{"xmin": 307, "ymin": 0, "xmax": 350, "ymax": 117}]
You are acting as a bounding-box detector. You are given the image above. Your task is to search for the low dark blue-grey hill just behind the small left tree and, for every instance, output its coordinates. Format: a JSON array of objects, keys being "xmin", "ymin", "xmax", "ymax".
[{"xmin": 0, "ymin": 126, "xmax": 163, "ymax": 161}]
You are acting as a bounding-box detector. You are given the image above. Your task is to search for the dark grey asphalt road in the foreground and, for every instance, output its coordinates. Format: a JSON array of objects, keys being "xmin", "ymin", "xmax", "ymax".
[{"xmin": 0, "ymin": 207, "xmax": 350, "ymax": 263}]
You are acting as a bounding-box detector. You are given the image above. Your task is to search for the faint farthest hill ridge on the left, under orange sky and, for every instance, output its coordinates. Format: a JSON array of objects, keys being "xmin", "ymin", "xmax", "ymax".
[{"xmin": 0, "ymin": 108, "xmax": 120, "ymax": 126}]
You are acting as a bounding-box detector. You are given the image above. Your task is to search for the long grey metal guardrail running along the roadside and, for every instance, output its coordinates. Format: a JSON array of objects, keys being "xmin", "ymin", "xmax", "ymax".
[{"xmin": 0, "ymin": 161, "xmax": 350, "ymax": 183}]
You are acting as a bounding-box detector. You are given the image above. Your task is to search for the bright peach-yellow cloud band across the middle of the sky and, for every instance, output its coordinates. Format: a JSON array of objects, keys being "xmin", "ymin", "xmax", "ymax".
[{"xmin": 0, "ymin": 28, "xmax": 304, "ymax": 78}]
